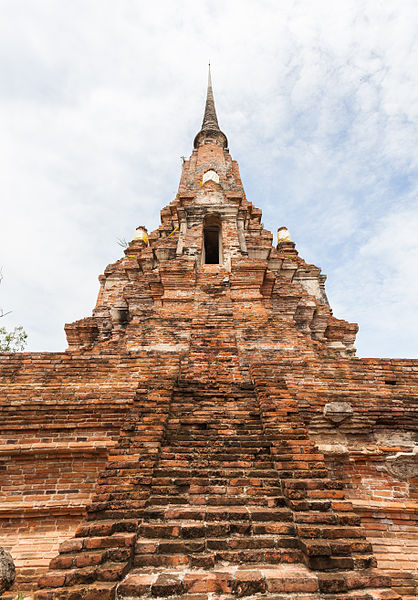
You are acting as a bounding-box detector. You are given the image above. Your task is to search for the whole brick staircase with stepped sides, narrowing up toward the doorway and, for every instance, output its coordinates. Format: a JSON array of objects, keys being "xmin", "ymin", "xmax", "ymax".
[{"xmin": 36, "ymin": 304, "xmax": 399, "ymax": 600}]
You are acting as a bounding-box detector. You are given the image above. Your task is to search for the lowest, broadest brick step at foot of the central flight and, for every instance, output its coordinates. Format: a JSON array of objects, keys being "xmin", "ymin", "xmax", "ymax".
[{"xmin": 116, "ymin": 564, "xmax": 319, "ymax": 600}]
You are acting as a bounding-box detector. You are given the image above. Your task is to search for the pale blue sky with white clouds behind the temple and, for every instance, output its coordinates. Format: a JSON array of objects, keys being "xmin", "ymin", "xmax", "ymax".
[{"xmin": 0, "ymin": 0, "xmax": 418, "ymax": 357}]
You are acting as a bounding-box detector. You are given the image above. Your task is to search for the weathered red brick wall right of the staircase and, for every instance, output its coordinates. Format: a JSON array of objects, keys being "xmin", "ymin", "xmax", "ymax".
[{"xmin": 290, "ymin": 359, "xmax": 418, "ymax": 600}]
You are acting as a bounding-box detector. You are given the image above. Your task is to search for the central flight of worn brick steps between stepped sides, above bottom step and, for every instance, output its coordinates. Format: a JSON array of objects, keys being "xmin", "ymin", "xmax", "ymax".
[{"xmin": 131, "ymin": 388, "xmax": 301, "ymax": 568}]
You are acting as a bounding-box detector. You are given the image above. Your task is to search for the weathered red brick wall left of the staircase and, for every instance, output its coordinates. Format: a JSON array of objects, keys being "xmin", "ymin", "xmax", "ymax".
[{"xmin": 0, "ymin": 353, "xmax": 167, "ymax": 586}]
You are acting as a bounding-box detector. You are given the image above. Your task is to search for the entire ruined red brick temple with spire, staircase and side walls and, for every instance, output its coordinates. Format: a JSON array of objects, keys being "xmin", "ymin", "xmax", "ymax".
[{"xmin": 0, "ymin": 68, "xmax": 418, "ymax": 600}]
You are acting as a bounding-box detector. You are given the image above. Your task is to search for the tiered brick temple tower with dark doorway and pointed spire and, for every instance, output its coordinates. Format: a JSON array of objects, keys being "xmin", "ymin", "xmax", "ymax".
[{"xmin": 66, "ymin": 65, "xmax": 358, "ymax": 356}]
